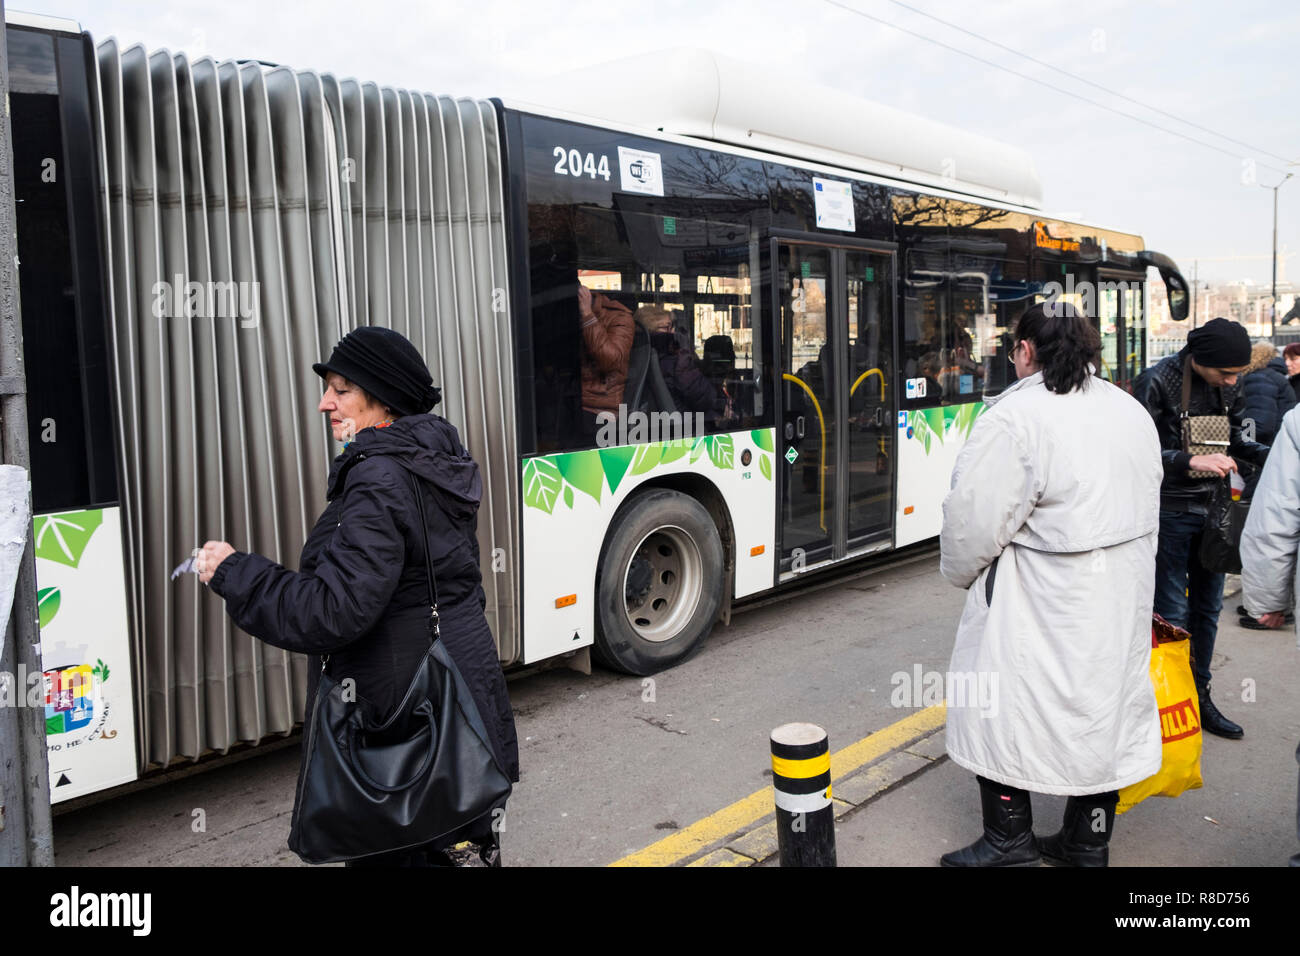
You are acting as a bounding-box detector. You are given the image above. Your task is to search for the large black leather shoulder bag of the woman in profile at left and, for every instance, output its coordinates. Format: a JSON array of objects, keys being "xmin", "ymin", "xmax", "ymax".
[{"xmin": 289, "ymin": 476, "xmax": 511, "ymax": 864}]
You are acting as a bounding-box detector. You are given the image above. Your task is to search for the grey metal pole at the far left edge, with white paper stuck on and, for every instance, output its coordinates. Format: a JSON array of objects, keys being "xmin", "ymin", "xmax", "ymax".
[{"xmin": 0, "ymin": 0, "xmax": 55, "ymax": 866}]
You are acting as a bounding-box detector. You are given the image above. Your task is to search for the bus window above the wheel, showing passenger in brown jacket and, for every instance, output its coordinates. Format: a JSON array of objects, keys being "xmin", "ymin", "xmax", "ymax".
[{"xmin": 529, "ymin": 205, "xmax": 766, "ymax": 451}]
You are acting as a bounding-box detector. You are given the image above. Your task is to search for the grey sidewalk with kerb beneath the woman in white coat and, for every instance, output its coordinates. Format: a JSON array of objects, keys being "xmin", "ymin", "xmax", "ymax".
[{"xmin": 707, "ymin": 594, "xmax": 1300, "ymax": 866}]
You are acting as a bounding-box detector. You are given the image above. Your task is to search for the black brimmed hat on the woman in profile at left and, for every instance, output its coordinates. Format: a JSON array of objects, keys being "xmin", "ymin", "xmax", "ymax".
[{"xmin": 312, "ymin": 325, "xmax": 442, "ymax": 415}]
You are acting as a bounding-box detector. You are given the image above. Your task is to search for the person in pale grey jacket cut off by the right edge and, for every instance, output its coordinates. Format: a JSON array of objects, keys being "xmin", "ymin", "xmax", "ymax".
[{"xmin": 1242, "ymin": 408, "xmax": 1300, "ymax": 866}]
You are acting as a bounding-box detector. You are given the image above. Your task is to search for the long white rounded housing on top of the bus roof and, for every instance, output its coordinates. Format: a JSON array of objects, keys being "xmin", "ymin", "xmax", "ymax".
[{"xmin": 511, "ymin": 49, "xmax": 1043, "ymax": 209}]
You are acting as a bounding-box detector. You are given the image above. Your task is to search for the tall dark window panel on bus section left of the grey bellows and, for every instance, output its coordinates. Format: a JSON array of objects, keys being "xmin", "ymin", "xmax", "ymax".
[{"xmin": 8, "ymin": 27, "xmax": 117, "ymax": 512}]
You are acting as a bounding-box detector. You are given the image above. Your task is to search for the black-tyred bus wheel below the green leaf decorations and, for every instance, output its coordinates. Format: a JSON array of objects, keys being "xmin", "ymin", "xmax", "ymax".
[{"xmin": 595, "ymin": 489, "xmax": 724, "ymax": 674}]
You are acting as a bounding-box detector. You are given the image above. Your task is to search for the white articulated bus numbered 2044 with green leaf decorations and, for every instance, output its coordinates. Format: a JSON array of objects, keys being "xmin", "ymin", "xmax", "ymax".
[{"xmin": 8, "ymin": 14, "xmax": 1186, "ymax": 801}]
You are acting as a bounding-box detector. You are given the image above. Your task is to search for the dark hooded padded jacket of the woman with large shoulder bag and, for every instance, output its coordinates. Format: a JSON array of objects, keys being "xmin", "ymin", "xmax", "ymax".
[{"xmin": 209, "ymin": 415, "xmax": 519, "ymax": 780}]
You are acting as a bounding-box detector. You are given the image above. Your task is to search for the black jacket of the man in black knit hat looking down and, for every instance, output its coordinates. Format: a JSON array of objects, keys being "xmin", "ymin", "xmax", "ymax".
[{"xmin": 1134, "ymin": 349, "xmax": 1269, "ymax": 514}]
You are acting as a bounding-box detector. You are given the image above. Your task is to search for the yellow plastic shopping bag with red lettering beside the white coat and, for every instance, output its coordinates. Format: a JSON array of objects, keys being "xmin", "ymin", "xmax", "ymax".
[{"xmin": 1115, "ymin": 614, "xmax": 1201, "ymax": 813}]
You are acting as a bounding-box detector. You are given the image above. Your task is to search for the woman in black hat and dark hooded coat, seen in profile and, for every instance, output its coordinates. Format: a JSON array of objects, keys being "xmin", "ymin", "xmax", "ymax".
[{"xmin": 196, "ymin": 326, "xmax": 519, "ymax": 866}]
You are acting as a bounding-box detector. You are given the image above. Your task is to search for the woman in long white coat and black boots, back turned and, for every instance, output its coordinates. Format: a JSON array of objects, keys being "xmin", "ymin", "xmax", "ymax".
[{"xmin": 940, "ymin": 303, "xmax": 1164, "ymax": 866}]
